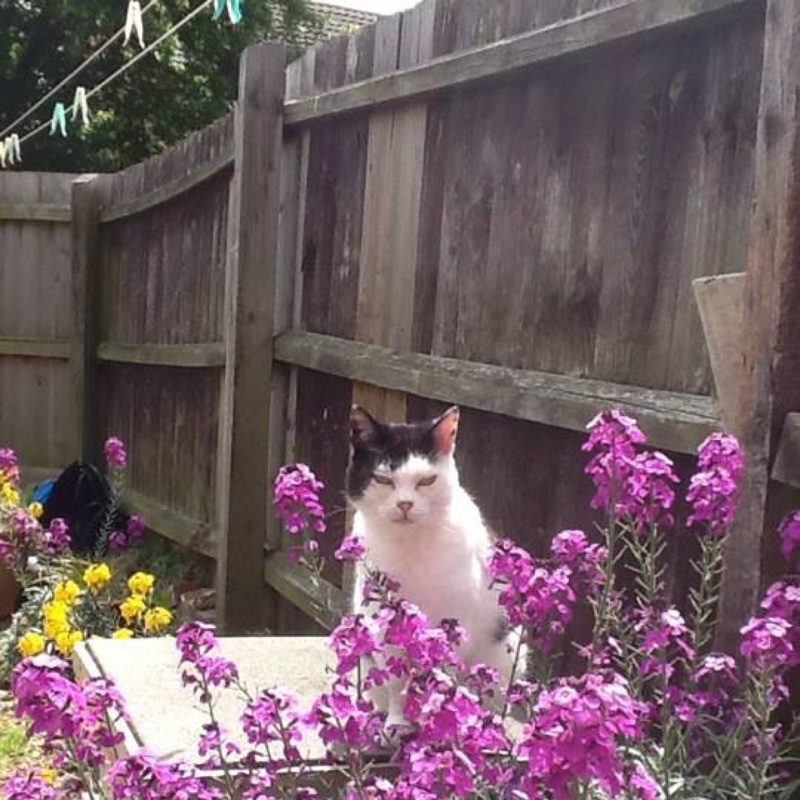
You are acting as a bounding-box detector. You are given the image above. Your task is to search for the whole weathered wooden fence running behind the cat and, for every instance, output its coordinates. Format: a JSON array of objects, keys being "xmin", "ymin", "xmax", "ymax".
[{"xmin": 0, "ymin": 0, "xmax": 800, "ymax": 639}]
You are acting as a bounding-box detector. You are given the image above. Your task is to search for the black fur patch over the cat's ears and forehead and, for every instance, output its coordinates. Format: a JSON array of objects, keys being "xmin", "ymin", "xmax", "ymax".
[{"xmin": 346, "ymin": 406, "xmax": 452, "ymax": 500}]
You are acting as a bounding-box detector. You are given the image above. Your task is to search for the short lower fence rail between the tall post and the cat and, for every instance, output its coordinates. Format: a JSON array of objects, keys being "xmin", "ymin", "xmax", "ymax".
[{"xmin": 264, "ymin": 552, "xmax": 347, "ymax": 630}]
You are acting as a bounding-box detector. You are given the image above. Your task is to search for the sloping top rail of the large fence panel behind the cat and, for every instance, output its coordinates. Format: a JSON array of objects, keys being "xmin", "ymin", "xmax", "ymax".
[{"xmin": 285, "ymin": 0, "xmax": 756, "ymax": 127}]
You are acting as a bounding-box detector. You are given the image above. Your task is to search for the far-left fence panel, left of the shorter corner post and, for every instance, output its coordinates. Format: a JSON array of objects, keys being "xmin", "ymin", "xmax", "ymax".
[{"xmin": 0, "ymin": 172, "xmax": 75, "ymax": 471}]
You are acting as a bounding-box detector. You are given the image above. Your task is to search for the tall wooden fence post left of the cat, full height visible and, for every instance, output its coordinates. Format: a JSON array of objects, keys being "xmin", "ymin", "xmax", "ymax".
[{"xmin": 217, "ymin": 44, "xmax": 285, "ymax": 634}]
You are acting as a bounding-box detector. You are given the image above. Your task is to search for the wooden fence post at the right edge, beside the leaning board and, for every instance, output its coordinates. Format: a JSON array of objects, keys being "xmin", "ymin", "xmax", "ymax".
[{"xmin": 718, "ymin": 0, "xmax": 800, "ymax": 650}]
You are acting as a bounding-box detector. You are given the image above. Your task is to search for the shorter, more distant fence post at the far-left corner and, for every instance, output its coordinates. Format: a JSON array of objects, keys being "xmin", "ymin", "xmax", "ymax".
[{"xmin": 70, "ymin": 175, "xmax": 102, "ymax": 461}]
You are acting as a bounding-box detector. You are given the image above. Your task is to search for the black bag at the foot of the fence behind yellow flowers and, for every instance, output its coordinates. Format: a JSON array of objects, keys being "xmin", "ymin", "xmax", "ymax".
[{"xmin": 41, "ymin": 461, "xmax": 128, "ymax": 555}]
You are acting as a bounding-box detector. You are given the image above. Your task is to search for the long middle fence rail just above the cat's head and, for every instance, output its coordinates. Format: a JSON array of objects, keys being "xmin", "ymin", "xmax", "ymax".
[{"xmin": 274, "ymin": 333, "xmax": 718, "ymax": 453}]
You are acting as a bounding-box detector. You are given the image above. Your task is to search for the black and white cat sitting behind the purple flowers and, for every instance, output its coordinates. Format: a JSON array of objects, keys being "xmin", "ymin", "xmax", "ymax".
[{"xmin": 347, "ymin": 406, "xmax": 524, "ymax": 723}]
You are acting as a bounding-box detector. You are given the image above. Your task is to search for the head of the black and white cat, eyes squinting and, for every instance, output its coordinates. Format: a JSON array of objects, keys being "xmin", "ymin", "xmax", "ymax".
[{"xmin": 347, "ymin": 406, "xmax": 459, "ymax": 533}]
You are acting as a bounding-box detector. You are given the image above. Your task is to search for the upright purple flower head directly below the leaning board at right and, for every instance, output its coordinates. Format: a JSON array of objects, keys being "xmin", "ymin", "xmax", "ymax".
[{"xmin": 686, "ymin": 433, "xmax": 744, "ymax": 538}]
